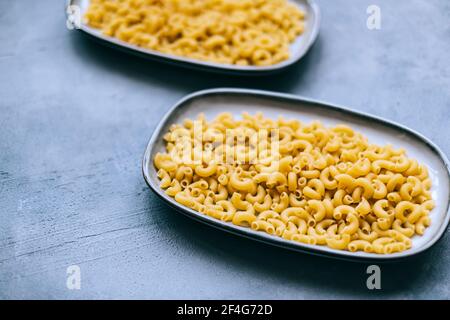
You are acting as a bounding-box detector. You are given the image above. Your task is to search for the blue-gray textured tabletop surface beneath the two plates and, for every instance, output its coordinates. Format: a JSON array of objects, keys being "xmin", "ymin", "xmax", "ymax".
[{"xmin": 0, "ymin": 0, "xmax": 450, "ymax": 299}]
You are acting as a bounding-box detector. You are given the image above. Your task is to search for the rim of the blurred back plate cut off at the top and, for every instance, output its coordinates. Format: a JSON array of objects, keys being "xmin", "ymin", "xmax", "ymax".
[{"xmin": 65, "ymin": 0, "xmax": 321, "ymax": 75}]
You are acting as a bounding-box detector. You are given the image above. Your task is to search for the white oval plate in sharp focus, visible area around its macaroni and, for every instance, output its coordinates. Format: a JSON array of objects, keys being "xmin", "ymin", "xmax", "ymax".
[{"xmin": 142, "ymin": 89, "xmax": 450, "ymax": 261}]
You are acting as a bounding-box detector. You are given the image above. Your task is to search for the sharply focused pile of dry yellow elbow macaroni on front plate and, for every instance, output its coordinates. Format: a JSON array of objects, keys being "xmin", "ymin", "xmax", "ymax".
[{"xmin": 154, "ymin": 113, "xmax": 434, "ymax": 254}]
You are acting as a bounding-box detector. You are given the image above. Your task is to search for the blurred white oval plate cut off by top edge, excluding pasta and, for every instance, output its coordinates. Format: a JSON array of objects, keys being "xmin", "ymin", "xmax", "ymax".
[{"xmin": 67, "ymin": 0, "xmax": 320, "ymax": 74}]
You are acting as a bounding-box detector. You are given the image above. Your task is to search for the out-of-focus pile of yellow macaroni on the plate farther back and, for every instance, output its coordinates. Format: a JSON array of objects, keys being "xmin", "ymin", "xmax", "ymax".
[{"xmin": 85, "ymin": 0, "xmax": 304, "ymax": 66}]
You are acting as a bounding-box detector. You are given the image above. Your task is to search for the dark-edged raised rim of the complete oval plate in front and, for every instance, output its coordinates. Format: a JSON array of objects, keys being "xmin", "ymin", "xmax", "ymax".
[{"xmin": 141, "ymin": 88, "xmax": 450, "ymax": 262}]
